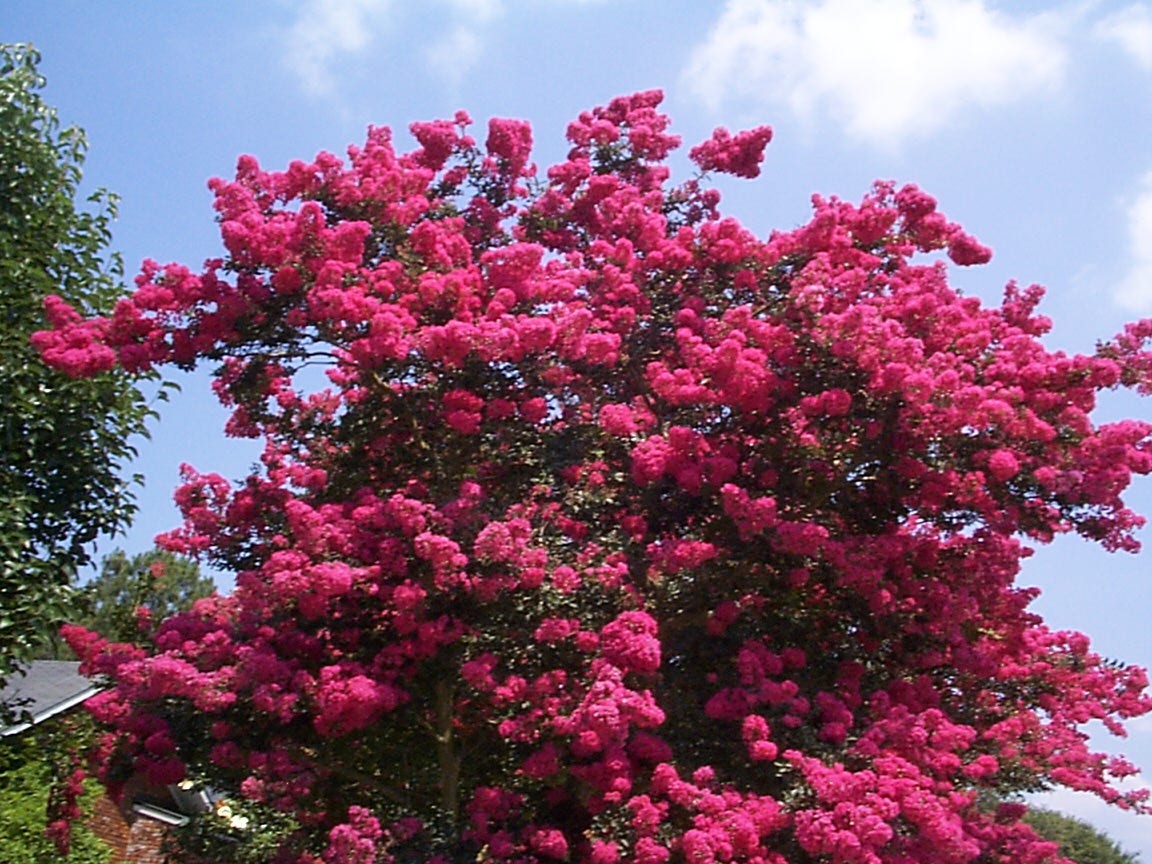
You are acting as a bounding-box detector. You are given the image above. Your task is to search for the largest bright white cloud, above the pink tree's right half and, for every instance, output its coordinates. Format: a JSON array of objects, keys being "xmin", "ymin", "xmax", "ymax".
[{"xmin": 684, "ymin": 0, "xmax": 1066, "ymax": 147}]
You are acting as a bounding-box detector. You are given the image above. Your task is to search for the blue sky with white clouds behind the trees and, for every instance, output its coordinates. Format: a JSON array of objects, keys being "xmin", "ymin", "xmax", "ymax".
[{"xmin": 0, "ymin": 0, "xmax": 1152, "ymax": 862}]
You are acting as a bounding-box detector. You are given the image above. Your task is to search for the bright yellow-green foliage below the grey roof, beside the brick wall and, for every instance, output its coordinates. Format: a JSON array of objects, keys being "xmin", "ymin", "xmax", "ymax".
[{"xmin": 0, "ymin": 735, "xmax": 112, "ymax": 864}]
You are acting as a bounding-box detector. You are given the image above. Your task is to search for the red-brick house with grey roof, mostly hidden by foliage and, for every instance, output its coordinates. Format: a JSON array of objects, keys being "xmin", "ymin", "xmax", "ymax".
[{"xmin": 0, "ymin": 660, "xmax": 210, "ymax": 864}]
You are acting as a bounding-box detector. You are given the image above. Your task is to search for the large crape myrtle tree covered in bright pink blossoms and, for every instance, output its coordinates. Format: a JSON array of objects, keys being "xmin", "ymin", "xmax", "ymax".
[{"xmin": 36, "ymin": 92, "xmax": 1152, "ymax": 864}]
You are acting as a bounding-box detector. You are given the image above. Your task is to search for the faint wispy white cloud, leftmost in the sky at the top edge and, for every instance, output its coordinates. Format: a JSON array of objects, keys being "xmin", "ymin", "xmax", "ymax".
[{"xmin": 286, "ymin": 0, "xmax": 391, "ymax": 96}]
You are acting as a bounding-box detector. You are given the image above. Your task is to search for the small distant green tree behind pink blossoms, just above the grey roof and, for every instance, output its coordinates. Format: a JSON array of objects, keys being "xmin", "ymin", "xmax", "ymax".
[{"xmin": 77, "ymin": 550, "xmax": 215, "ymax": 642}]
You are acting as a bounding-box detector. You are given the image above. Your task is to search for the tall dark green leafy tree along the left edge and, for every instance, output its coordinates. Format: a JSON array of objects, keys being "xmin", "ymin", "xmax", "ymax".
[{"xmin": 0, "ymin": 45, "xmax": 156, "ymax": 681}]
